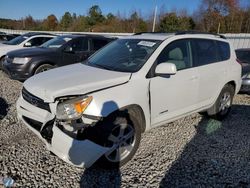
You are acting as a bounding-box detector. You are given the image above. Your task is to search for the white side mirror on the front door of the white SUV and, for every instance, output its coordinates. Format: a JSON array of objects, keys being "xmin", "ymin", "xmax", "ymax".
[{"xmin": 155, "ymin": 62, "xmax": 177, "ymax": 76}]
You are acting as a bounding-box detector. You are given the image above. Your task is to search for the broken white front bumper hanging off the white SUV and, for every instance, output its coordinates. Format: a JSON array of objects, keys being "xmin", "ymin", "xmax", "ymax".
[{"xmin": 17, "ymin": 96, "xmax": 110, "ymax": 168}]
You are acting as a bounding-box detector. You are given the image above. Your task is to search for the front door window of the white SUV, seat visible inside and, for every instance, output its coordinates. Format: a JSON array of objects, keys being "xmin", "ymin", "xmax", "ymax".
[{"xmin": 157, "ymin": 39, "xmax": 193, "ymax": 70}]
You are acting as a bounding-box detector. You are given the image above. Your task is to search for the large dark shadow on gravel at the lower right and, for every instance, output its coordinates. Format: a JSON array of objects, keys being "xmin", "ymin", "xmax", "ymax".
[{"xmin": 160, "ymin": 105, "xmax": 250, "ymax": 187}]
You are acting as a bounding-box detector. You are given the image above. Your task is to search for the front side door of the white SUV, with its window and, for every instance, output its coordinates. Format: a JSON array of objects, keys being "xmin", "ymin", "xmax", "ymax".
[{"xmin": 150, "ymin": 39, "xmax": 199, "ymax": 126}]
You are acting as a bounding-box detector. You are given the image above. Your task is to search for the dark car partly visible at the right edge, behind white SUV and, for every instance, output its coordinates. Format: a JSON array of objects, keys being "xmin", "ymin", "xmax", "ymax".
[{"xmin": 235, "ymin": 48, "xmax": 250, "ymax": 93}]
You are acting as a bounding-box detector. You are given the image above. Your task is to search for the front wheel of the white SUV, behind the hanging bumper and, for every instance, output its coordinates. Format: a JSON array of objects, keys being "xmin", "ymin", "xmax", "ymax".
[{"xmin": 95, "ymin": 112, "xmax": 141, "ymax": 169}]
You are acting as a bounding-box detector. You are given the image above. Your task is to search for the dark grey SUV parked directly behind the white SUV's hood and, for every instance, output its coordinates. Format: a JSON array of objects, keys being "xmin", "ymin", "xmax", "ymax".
[{"xmin": 3, "ymin": 35, "xmax": 115, "ymax": 81}]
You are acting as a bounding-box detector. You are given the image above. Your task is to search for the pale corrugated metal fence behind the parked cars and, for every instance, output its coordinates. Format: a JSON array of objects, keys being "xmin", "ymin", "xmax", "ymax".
[{"xmin": 0, "ymin": 29, "xmax": 250, "ymax": 49}]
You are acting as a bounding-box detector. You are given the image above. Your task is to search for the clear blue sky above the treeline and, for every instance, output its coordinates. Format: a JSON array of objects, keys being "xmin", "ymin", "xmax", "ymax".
[{"xmin": 0, "ymin": 0, "xmax": 249, "ymax": 19}]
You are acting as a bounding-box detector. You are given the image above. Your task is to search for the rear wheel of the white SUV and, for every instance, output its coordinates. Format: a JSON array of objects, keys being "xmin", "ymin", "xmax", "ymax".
[{"xmin": 208, "ymin": 84, "xmax": 234, "ymax": 120}]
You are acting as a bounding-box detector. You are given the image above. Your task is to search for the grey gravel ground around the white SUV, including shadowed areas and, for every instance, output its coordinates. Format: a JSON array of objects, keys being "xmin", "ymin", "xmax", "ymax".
[{"xmin": 0, "ymin": 71, "xmax": 250, "ymax": 187}]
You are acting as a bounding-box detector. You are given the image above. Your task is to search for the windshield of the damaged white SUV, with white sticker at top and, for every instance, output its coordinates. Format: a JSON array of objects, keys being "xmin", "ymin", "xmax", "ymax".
[{"xmin": 86, "ymin": 39, "xmax": 161, "ymax": 72}]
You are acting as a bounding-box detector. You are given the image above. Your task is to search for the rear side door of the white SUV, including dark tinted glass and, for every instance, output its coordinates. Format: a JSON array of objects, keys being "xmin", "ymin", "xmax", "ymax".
[{"xmin": 192, "ymin": 39, "xmax": 230, "ymax": 107}]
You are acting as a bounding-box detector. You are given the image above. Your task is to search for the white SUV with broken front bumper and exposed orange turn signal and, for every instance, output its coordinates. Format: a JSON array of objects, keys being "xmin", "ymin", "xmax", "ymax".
[{"xmin": 17, "ymin": 33, "xmax": 241, "ymax": 168}]
